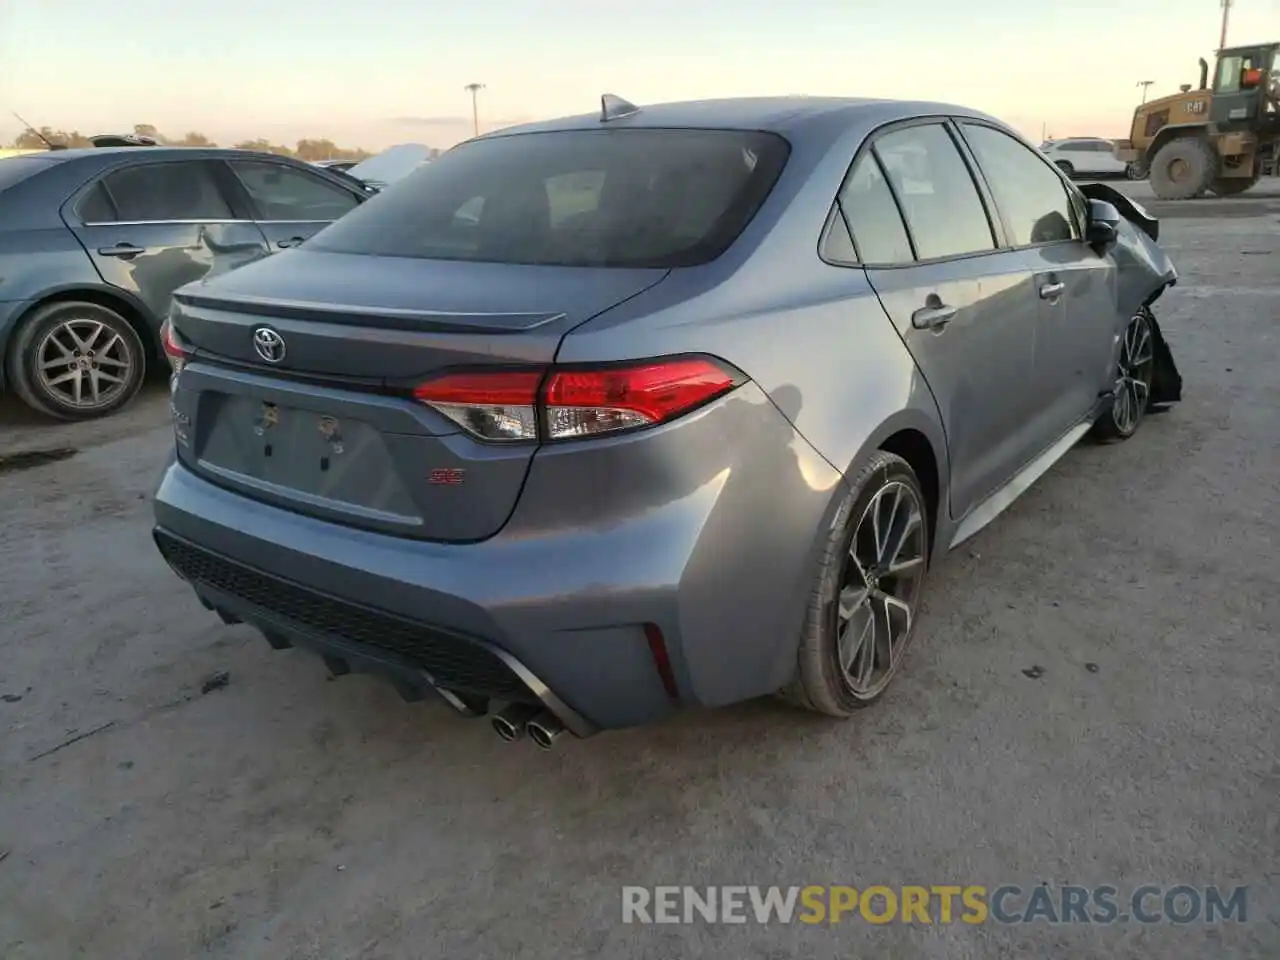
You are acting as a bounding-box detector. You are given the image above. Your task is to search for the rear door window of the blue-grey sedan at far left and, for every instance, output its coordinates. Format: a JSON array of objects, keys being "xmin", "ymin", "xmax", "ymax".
[{"xmin": 102, "ymin": 160, "xmax": 233, "ymax": 223}]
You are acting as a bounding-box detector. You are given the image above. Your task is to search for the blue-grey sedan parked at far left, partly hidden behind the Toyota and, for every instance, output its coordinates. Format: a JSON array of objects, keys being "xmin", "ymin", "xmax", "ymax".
[{"xmin": 0, "ymin": 145, "xmax": 367, "ymax": 420}]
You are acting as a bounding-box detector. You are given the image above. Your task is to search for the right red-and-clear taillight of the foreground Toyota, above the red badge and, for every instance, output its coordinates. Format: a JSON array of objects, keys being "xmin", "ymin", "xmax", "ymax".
[{"xmin": 413, "ymin": 357, "xmax": 741, "ymax": 440}]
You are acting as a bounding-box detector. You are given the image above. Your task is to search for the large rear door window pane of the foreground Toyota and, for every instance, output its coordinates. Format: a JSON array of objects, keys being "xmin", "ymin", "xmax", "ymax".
[{"xmin": 873, "ymin": 123, "xmax": 996, "ymax": 260}]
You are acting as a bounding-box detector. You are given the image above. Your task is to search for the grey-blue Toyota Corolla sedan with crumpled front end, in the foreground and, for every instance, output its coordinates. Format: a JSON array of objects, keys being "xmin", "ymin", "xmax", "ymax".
[{"xmin": 147, "ymin": 96, "xmax": 1181, "ymax": 746}]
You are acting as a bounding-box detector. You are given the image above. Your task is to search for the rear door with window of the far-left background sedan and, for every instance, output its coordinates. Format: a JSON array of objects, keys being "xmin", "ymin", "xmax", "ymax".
[{"xmin": 63, "ymin": 157, "xmax": 266, "ymax": 324}]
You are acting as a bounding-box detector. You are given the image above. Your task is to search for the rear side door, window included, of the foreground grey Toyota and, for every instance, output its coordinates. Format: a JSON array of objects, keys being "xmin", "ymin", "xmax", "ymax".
[{"xmin": 840, "ymin": 120, "xmax": 1038, "ymax": 527}]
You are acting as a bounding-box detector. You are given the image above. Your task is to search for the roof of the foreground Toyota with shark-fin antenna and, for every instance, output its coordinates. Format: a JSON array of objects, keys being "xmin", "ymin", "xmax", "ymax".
[{"xmin": 480, "ymin": 96, "xmax": 1000, "ymax": 140}]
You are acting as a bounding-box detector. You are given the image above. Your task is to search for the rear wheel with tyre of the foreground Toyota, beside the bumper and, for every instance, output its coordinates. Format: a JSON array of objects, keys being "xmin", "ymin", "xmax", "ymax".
[{"xmin": 782, "ymin": 452, "xmax": 931, "ymax": 717}]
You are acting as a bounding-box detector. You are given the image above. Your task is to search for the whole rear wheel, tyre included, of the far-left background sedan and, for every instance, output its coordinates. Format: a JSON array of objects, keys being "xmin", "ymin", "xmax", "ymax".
[{"xmin": 9, "ymin": 301, "xmax": 146, "ymax": 420}]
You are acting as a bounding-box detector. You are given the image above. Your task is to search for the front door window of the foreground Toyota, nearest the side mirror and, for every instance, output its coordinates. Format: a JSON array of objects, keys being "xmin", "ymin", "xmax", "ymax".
[{"xmin": 963, "ymin": 123, "xmax": 1079, "ymax": 247}]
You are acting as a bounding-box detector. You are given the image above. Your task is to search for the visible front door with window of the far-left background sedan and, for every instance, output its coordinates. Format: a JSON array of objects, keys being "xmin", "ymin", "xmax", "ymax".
[{"xmin": 227, "ymin": 159, "xmax": 361, "ymax": 251}]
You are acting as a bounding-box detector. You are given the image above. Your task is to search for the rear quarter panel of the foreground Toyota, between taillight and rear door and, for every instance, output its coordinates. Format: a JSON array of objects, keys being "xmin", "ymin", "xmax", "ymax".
[{"xmin": 557, "ymin": 120, "xmax": 947, "ymax": 519}]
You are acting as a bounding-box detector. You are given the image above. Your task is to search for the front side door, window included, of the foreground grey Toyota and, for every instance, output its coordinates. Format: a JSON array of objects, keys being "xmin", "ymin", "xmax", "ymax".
[{"xmin": 960, "ymin": 120, "xmax": 1119, "ymax": 445}]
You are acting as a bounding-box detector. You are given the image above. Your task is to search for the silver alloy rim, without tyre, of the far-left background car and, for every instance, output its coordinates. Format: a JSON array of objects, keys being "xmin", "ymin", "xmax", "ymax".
[{"xmin": 36, "ymin": 317, "xmax": 136, "ymax": 410}]
